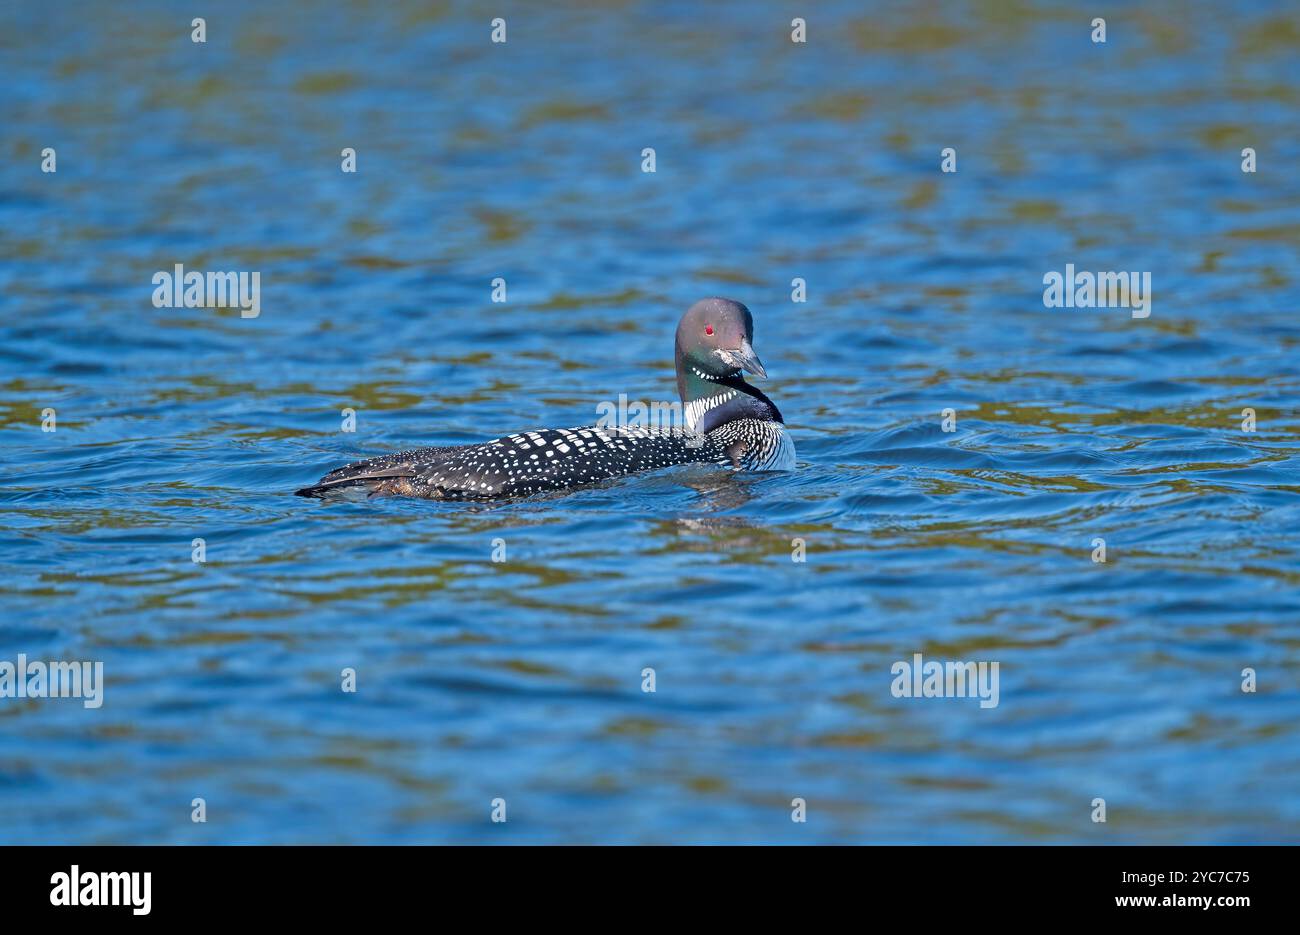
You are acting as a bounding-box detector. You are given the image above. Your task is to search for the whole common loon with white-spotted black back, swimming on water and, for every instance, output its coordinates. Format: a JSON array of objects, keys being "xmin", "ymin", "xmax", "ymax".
[{"xmin": 296, "ymin": 298, "xmax": 794, "ymax": 501}]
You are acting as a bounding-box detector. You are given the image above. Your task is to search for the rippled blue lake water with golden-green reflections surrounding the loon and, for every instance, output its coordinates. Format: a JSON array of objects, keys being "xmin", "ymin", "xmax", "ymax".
[{"xmin": 0, "ymin": 0, "xmax": 1300, "ymax": 843}]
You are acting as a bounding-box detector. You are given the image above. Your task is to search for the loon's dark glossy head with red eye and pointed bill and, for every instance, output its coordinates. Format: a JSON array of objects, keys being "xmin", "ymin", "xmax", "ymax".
[{"xmin": 676, "ymin": 298, "xmax": 781, "ymax": 421}]
